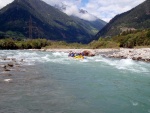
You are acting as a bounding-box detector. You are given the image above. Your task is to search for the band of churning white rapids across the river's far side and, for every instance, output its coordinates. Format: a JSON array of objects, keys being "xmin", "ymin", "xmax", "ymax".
[{"xmin": 0, "ymin": 50, "xmax": 150, "ymax": 73}]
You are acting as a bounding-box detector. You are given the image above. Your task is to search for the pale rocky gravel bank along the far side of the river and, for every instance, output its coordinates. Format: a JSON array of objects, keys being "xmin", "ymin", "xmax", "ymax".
[{"xmin": 32, "ymin": 48, "xmax": 150, "ymax": 62}]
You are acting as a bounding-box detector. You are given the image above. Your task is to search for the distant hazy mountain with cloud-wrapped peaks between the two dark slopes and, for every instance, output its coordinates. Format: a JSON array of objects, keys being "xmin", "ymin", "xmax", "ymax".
[{"xmin": 54, "ymin": 3, "xmax": 107, "ymax": 35}]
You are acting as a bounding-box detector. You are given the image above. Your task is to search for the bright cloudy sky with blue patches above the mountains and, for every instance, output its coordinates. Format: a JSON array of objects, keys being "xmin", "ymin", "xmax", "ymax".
[{"xmin": 0, "ymin": 0, "xmax": 145, "ymax": 22}]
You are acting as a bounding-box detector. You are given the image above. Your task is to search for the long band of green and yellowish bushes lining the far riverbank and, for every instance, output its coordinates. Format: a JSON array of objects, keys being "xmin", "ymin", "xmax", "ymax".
[{"xmin": 0, "ymin": 29, "xmax": 150, "ymax": 49}]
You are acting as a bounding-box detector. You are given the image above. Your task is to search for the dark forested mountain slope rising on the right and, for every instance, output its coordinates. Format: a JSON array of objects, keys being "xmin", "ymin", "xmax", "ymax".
[{"xmin": 95, "ymin": 0, "xmax": 150, "ymax": 39}]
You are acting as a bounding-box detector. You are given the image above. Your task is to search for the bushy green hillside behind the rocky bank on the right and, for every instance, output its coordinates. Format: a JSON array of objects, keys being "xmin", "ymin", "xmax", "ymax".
[{"xmin": 89, "ymin": 29, "xmax": 150, "ymax": 49}]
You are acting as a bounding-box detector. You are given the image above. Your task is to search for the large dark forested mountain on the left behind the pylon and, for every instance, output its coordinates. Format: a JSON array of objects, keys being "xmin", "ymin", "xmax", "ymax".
[{"xmin": 0, "ymin": 0, "xmax": 100, "ymax": 43}]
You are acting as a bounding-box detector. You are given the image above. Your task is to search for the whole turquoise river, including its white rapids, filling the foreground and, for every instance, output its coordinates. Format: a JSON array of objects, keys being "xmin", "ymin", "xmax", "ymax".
[{"xmin": 0, "ymin": 50, "xmax": 150, "ymax": 113}]
